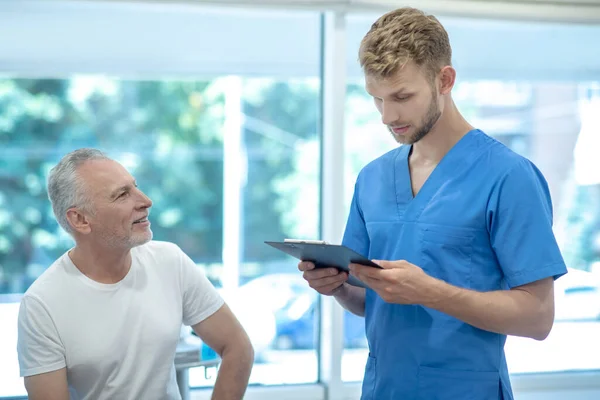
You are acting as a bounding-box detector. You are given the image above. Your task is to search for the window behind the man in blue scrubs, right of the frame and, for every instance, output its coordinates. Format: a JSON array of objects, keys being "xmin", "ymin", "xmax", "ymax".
[{"xmin": 342, "ymin": 16, "xmax": 600, "ymax": 381}]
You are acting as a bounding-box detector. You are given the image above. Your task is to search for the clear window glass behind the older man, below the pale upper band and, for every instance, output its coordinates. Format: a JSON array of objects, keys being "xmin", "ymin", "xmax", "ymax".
[{"xmin": 0, "ymin": 76, "xmax": 320, "ymax": 396}]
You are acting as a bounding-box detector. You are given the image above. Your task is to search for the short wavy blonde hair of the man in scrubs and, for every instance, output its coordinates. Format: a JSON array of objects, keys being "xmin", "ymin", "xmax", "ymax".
[{"xmin": 359, "ymin": 7, "xmax": 452, "ymax": 79}]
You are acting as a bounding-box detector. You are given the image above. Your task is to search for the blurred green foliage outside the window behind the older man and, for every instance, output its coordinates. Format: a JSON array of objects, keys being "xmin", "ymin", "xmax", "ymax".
[{"xmin": 0, "ymin": 76, "xmax": 319, "ymax": 294}]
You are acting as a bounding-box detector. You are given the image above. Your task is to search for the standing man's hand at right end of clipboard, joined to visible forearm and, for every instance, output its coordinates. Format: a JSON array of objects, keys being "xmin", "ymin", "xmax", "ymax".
[{"xmin": 350, "ymin": 260, "xmax": 436, "ymax": 304}]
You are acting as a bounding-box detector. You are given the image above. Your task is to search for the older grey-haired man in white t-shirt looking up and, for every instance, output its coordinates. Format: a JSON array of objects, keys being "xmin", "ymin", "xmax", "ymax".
[{"xmin": 18, "ymin": 149, "xmax": 254, "ymax": 400}]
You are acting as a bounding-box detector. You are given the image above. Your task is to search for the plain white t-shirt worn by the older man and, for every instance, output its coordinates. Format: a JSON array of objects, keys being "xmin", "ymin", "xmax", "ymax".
[{"xmin": 18, "ymin": 241, "xmax": 223, "ymax": 400}]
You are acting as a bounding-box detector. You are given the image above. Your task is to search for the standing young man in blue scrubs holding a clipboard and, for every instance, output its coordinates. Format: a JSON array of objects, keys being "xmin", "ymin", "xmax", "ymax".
[{"xmin": 299, "ymin": 8, "xmax": 566, "ymax": 400}]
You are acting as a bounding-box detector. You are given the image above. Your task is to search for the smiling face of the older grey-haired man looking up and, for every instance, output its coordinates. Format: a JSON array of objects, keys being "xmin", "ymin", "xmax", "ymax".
[{"xmin": 78, "ymin": 160, "xmax": 152, "ymax": 249}]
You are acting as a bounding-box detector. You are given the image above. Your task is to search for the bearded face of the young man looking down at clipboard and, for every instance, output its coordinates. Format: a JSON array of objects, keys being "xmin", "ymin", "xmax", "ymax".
[{"xmin": 365, "ymin": 62, "xmax": 442, "ymax": 144}]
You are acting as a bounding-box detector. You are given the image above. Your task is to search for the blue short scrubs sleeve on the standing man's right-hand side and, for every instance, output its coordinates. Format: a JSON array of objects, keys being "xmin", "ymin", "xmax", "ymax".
[{"xmin": 487, "ymin": 159, "xmax": 567, "ymax": 288}]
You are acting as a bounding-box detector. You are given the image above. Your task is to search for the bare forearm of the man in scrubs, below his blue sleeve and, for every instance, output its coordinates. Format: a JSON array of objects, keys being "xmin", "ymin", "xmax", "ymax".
[{"xmin": 423, "ymin": 279, "xmax": 554, "ymax": 340}]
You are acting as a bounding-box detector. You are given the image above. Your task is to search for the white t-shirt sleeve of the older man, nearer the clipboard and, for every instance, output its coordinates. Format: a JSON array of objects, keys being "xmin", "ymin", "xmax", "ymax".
[{"xmin": 178, "ymin": 248, "xmax": 224, "ymax": 326}]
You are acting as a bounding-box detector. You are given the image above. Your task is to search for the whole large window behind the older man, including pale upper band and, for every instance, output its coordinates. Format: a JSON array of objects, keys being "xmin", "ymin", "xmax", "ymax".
[{"xmin": 0, "ymin": 4, "xmax": 321, "ymax": 397}]
